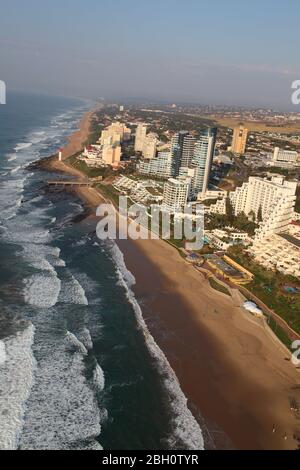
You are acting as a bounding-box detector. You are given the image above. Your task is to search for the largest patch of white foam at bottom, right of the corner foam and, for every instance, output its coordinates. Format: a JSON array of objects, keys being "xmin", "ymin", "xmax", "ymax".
[{"xmin": 20, "ymin": 328, "xmax": 102, "ymax": 450}]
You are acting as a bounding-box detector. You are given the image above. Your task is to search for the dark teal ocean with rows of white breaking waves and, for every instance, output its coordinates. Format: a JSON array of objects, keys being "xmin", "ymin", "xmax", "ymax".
[{"xmin": 0, "ymin": 93, "xmax": 203, "ymax": 450}]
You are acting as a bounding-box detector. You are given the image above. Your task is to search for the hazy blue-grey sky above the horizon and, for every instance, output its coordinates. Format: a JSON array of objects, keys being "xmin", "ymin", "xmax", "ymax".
[{"xmin": 0, "ymin": 0, "xmax": 300, "ymax": 111}]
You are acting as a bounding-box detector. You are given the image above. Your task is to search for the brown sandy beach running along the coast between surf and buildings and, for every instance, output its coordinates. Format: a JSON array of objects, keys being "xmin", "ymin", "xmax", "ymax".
[{"xmin": 37, "ymin": 105, "xmax": 300, "ymax": 449}]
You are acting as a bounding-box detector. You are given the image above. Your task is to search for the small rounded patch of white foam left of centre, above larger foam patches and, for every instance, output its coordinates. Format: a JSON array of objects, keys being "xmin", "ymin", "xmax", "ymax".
[{"xmin": 24, "ymin": 272, "xmax": 61, "ymax": 308}]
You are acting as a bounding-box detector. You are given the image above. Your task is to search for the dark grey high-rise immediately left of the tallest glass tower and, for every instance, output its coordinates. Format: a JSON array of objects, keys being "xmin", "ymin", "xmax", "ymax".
[{"xmin": 171, "ymin": 131, "xmax": 195, "ymax": 176}]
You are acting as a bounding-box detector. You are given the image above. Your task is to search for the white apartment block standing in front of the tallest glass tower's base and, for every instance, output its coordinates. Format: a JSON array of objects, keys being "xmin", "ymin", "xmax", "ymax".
[{"xmin": 162, "ymin": 178, "xmax": 190, "ymax": 213}]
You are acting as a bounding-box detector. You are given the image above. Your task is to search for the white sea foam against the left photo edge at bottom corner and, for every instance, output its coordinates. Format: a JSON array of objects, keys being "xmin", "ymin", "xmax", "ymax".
[{"xmin": 0, "ymin": 325, "xmax": 36, "ymax": 450}]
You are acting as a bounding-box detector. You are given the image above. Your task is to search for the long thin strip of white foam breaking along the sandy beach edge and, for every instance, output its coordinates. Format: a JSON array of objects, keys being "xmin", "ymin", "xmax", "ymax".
[{"xmin": 111, "ymin": 243, "xmax": 204, "ymax": 450}]
